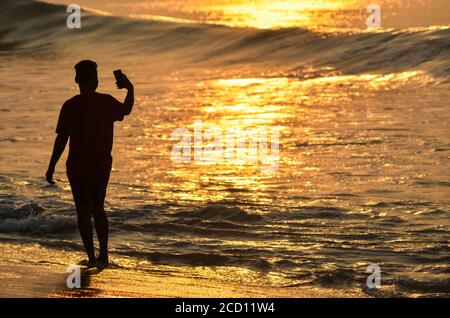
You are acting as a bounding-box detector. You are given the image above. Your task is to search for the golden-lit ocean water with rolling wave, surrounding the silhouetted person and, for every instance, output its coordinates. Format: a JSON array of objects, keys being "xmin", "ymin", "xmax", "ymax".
[{"xmin": 0, "ymin": 0, "xmax": 450, "ymax": 296}]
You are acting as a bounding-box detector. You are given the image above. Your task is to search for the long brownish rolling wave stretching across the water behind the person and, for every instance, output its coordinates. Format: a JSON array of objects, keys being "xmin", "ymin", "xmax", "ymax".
[{"xmin": 0, "ymin": 0, "xmax": 450, "ymax": 79}]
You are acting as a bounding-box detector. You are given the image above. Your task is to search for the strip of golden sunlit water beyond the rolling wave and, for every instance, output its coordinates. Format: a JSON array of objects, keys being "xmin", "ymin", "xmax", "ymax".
[{"xmin": 46, "ymin": 0, "xmax": 450, "ymax": 31}]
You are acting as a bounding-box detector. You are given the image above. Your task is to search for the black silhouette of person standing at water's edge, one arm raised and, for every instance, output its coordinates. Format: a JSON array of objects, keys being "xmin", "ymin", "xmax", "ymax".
[{"xmin": 46, "ymin": 60, "xmax": 134, "ymax": 266}]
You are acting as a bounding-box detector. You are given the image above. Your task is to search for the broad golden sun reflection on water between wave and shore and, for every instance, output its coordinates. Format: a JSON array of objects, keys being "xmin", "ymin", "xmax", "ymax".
[{"xmin": 121, "ymin": 72, "xmax": 434, "ymax": 205}]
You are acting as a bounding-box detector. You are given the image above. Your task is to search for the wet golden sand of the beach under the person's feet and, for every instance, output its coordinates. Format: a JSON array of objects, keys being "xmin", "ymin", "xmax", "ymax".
[{"xmin": 0, "ymin": 243, "xmax": 367, "ymax": 298}]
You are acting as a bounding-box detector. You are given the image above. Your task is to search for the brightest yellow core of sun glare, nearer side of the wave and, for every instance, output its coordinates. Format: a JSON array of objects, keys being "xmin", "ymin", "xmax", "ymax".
[{"xmin": 164, "ymin": 78, "xmax": 296, "ymax": 203}]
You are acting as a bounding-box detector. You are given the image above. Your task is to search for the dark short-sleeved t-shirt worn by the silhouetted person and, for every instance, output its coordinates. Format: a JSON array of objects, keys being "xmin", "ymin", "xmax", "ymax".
[{"xmin": 56, "ymin": 93, "xmax": 125, "ymax": 172}]
